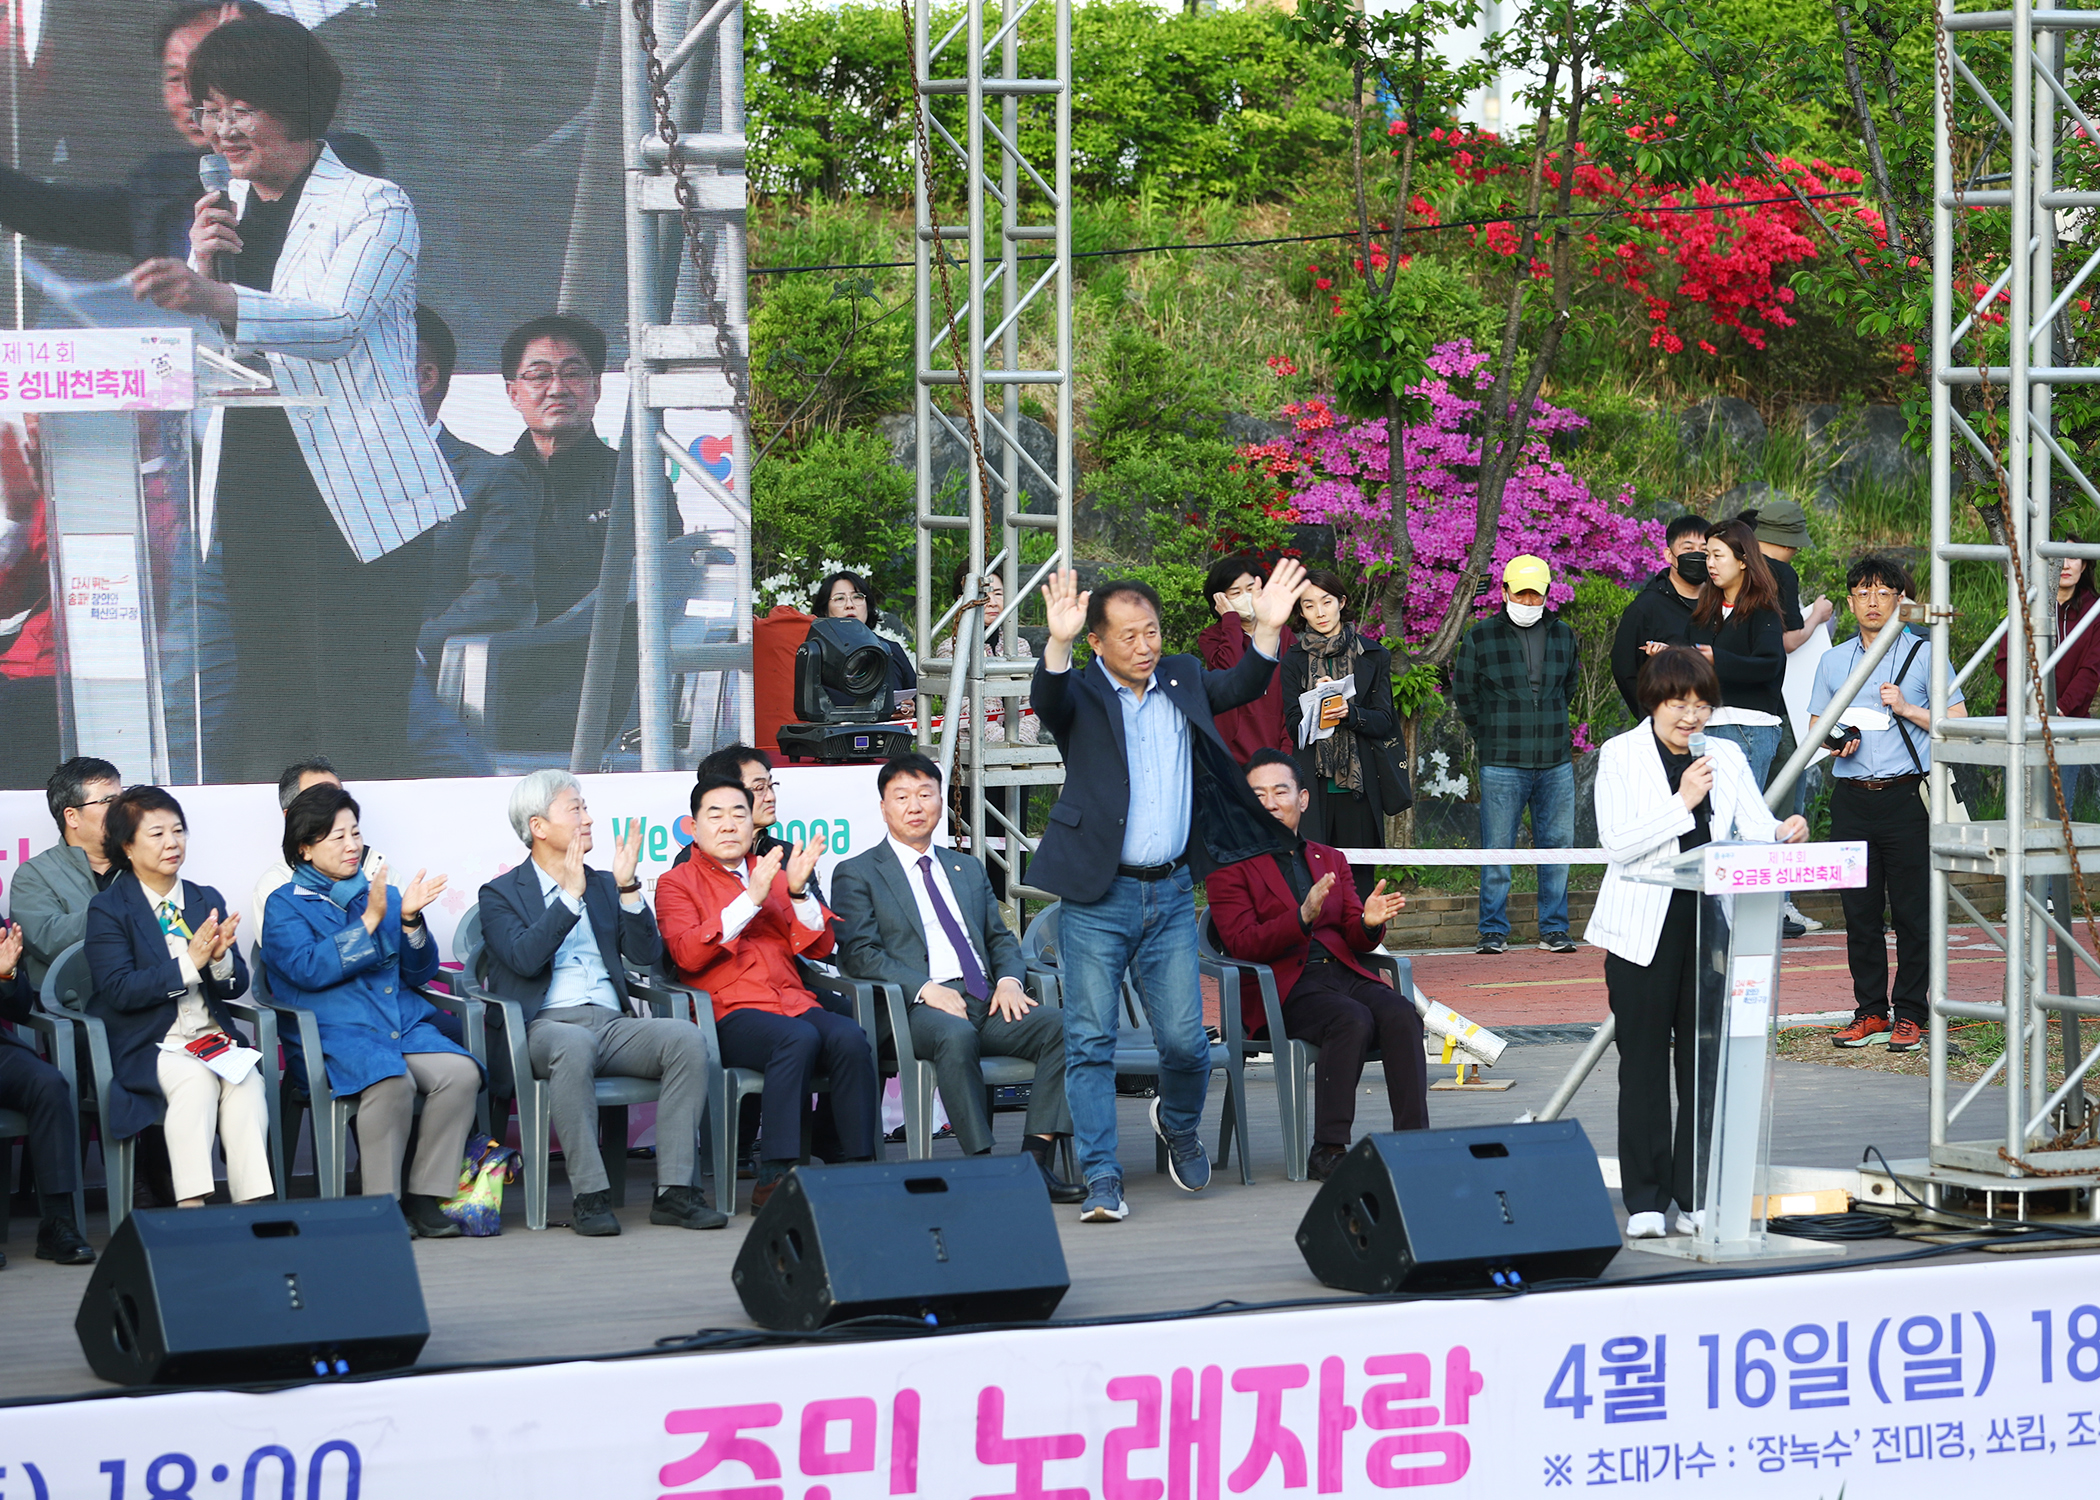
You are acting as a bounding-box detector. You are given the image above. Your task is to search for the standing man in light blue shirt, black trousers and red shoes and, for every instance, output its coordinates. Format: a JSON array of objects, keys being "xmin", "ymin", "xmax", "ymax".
[{"xmin": 1810, "ymin": 555, "xmax": 1968, "ymax": 1053}]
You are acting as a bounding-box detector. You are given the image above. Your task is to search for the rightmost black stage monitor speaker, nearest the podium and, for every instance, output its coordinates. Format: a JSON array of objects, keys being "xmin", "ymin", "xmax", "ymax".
[{"xmin": 1298, "ymin": 1120, "xmax": 1621, "ymax": 1292}]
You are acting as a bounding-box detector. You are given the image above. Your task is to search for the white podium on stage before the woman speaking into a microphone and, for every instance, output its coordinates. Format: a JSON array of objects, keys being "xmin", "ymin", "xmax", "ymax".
[{"xmin": 1630, "ymin": 842, "xmax": 1867, "ymax": 1263}]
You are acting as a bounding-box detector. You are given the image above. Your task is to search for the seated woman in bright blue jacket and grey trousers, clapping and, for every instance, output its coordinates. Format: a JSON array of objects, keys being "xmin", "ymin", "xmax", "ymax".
[{"xmin": 260, "ymin": 784, "xmax": 481, "ymax": 1239}]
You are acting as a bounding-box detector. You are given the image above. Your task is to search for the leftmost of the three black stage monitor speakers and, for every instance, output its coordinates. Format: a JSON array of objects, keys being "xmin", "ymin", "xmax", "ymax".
[{"xmin": 74, "ymin": 1197, "xmax": 431, "ymax": 1384}]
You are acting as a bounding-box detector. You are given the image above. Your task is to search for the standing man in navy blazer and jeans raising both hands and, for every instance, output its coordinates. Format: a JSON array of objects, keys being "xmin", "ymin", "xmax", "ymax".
[{"xmin": 1027, "ymin": 557, "xmax": 1306, "ymax": 1223}]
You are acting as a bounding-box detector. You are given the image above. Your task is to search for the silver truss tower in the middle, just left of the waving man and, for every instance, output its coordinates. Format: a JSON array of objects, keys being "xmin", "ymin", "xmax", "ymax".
[{"xmin": 911, "ymin": 0, "xmax": 1073, "ymax": 899}]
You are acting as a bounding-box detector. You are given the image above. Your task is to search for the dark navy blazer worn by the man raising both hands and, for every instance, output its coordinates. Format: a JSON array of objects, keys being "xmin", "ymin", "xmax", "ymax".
[{"xmin": 1029, "ymin": 651, "xmax": 1283, "ymax": 901}]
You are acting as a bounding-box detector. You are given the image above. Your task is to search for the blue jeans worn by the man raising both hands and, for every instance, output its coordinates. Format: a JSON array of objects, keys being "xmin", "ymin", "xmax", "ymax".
[{"xmin": 1058, "ymin": 866, "xmax": 1210, "ymax": 1183}]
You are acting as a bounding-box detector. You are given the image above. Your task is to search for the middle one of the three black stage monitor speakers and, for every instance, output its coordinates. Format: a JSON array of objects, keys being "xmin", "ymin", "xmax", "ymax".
[{"xmin": 731, "ymin": 1155, "xmax": 1071, "ymax": 1330}]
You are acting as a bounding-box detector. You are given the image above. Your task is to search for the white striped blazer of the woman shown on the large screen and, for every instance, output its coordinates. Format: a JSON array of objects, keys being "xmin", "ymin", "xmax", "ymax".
[{"xmin": 200, "ymin": 145, "xmax": 464, "ymax": 563}]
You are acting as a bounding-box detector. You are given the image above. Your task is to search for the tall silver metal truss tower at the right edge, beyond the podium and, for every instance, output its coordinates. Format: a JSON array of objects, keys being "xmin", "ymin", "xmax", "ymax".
[{"xmin": 1923, "ymin": 0, "xmax": 2100, "ymax": 1216}]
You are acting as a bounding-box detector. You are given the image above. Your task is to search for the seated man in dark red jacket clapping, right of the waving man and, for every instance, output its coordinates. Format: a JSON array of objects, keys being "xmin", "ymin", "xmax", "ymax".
[{"xmin": 1203, "ymin": 750, "xmax": 1430, "ymax": 1183}]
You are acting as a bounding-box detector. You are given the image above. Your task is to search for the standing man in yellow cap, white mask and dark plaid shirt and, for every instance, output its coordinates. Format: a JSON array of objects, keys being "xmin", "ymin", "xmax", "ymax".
[{"xmin": 1451, "ymin": 555, "xmax": 1577, "ymax": 954}]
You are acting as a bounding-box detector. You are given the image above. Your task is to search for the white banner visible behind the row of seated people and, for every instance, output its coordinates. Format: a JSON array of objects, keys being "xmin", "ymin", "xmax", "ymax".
[{"xmin": 0, "ymin": 765, "xmax": 884, "ymax": 953}]
